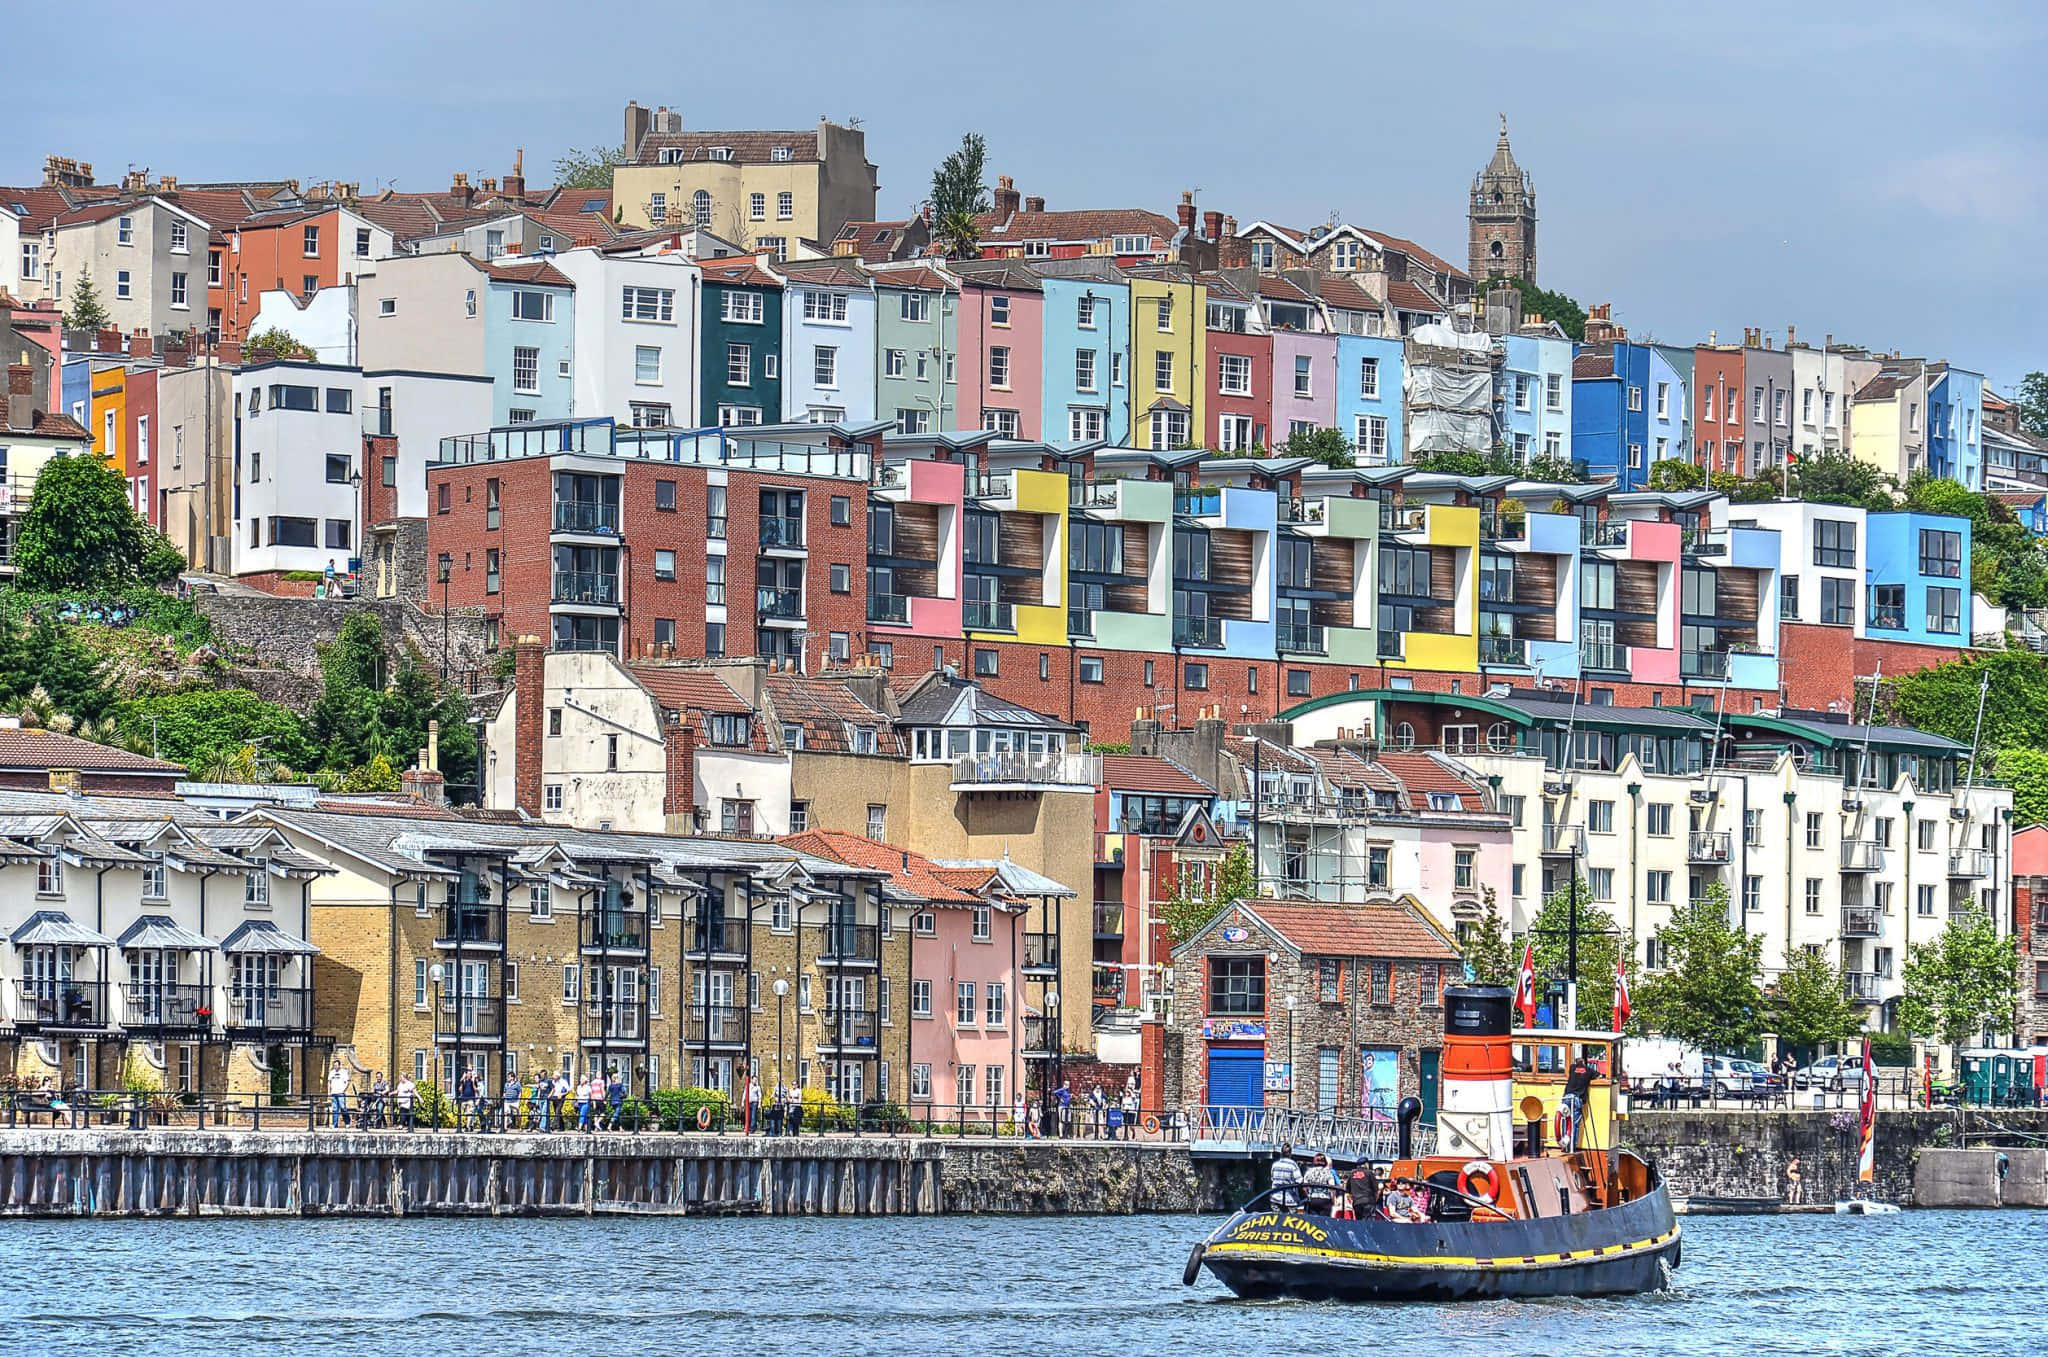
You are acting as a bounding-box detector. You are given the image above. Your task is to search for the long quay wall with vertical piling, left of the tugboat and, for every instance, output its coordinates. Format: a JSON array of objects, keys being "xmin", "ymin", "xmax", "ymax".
[{"xmin": 0, "ymin": 1130, "xmax": 1253, "ymax": 1216}]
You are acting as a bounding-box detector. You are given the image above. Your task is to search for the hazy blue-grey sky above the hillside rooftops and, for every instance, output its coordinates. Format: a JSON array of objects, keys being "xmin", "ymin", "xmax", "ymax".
[{"xmin": 16, "ymin": 0, "xmax": 2048, "ymax": 391}]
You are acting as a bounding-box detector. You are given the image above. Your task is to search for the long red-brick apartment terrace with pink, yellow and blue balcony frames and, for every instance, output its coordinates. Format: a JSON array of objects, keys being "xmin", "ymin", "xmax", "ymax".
[{"xmin": 426, "ymin": 420, "xmax": 1970, "ymax": 745}]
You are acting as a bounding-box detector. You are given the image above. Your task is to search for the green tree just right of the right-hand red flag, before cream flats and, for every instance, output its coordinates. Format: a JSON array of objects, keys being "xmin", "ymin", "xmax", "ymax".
[{"xmin": 1636, "ymin": 882, "xmax": 1763, "ymax": 1052}]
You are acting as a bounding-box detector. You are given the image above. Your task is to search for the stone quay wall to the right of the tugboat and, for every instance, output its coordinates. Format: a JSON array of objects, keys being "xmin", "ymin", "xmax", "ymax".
[{"xmin": 1620, "ymin": 1105, "xmax": 2048, "ymax": 1206}]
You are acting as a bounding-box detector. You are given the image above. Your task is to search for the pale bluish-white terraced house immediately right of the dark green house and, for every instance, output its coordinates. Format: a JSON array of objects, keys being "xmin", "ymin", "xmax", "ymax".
[{"xmin": 776, "ymin": 258, "xmax": 876, "ymax": 424}]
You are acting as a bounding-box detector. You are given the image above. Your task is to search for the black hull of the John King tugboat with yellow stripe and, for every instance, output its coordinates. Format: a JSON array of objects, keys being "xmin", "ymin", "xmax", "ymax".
[{"xmin": 1200, "ymin": 1185, "xmax": 1679, "ymax": 1300}]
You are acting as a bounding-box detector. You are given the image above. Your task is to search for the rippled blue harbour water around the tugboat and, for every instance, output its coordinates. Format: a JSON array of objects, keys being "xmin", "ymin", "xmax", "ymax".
[{"xmin": 0, "ymin": 1212, "xmax": 2048, "ymax": 1357}]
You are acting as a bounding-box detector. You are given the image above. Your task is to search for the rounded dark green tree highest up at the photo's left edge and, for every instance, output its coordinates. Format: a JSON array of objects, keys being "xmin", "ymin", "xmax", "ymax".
[{"xmin": 14, "ymin": 456, "xmax": 163, "ymax": 594}]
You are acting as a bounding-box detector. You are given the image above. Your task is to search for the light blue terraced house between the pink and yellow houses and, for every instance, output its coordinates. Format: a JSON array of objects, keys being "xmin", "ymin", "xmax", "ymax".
[{"xmin": 1034, "ymin": 258, "xmax": 1130, "ymax": 442}]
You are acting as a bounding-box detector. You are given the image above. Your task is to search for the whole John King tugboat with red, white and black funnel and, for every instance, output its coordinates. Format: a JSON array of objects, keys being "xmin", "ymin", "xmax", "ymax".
[{"xmin": 1182, "ymin": 984, "xmax": 1679, "ymax": 1300}]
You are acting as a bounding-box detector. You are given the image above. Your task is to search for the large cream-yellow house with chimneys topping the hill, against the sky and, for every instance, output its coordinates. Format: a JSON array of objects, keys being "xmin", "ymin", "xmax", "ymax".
[{"xmin": 612, "ymin": 104, "xmax": 877, "ymax": 246}]
